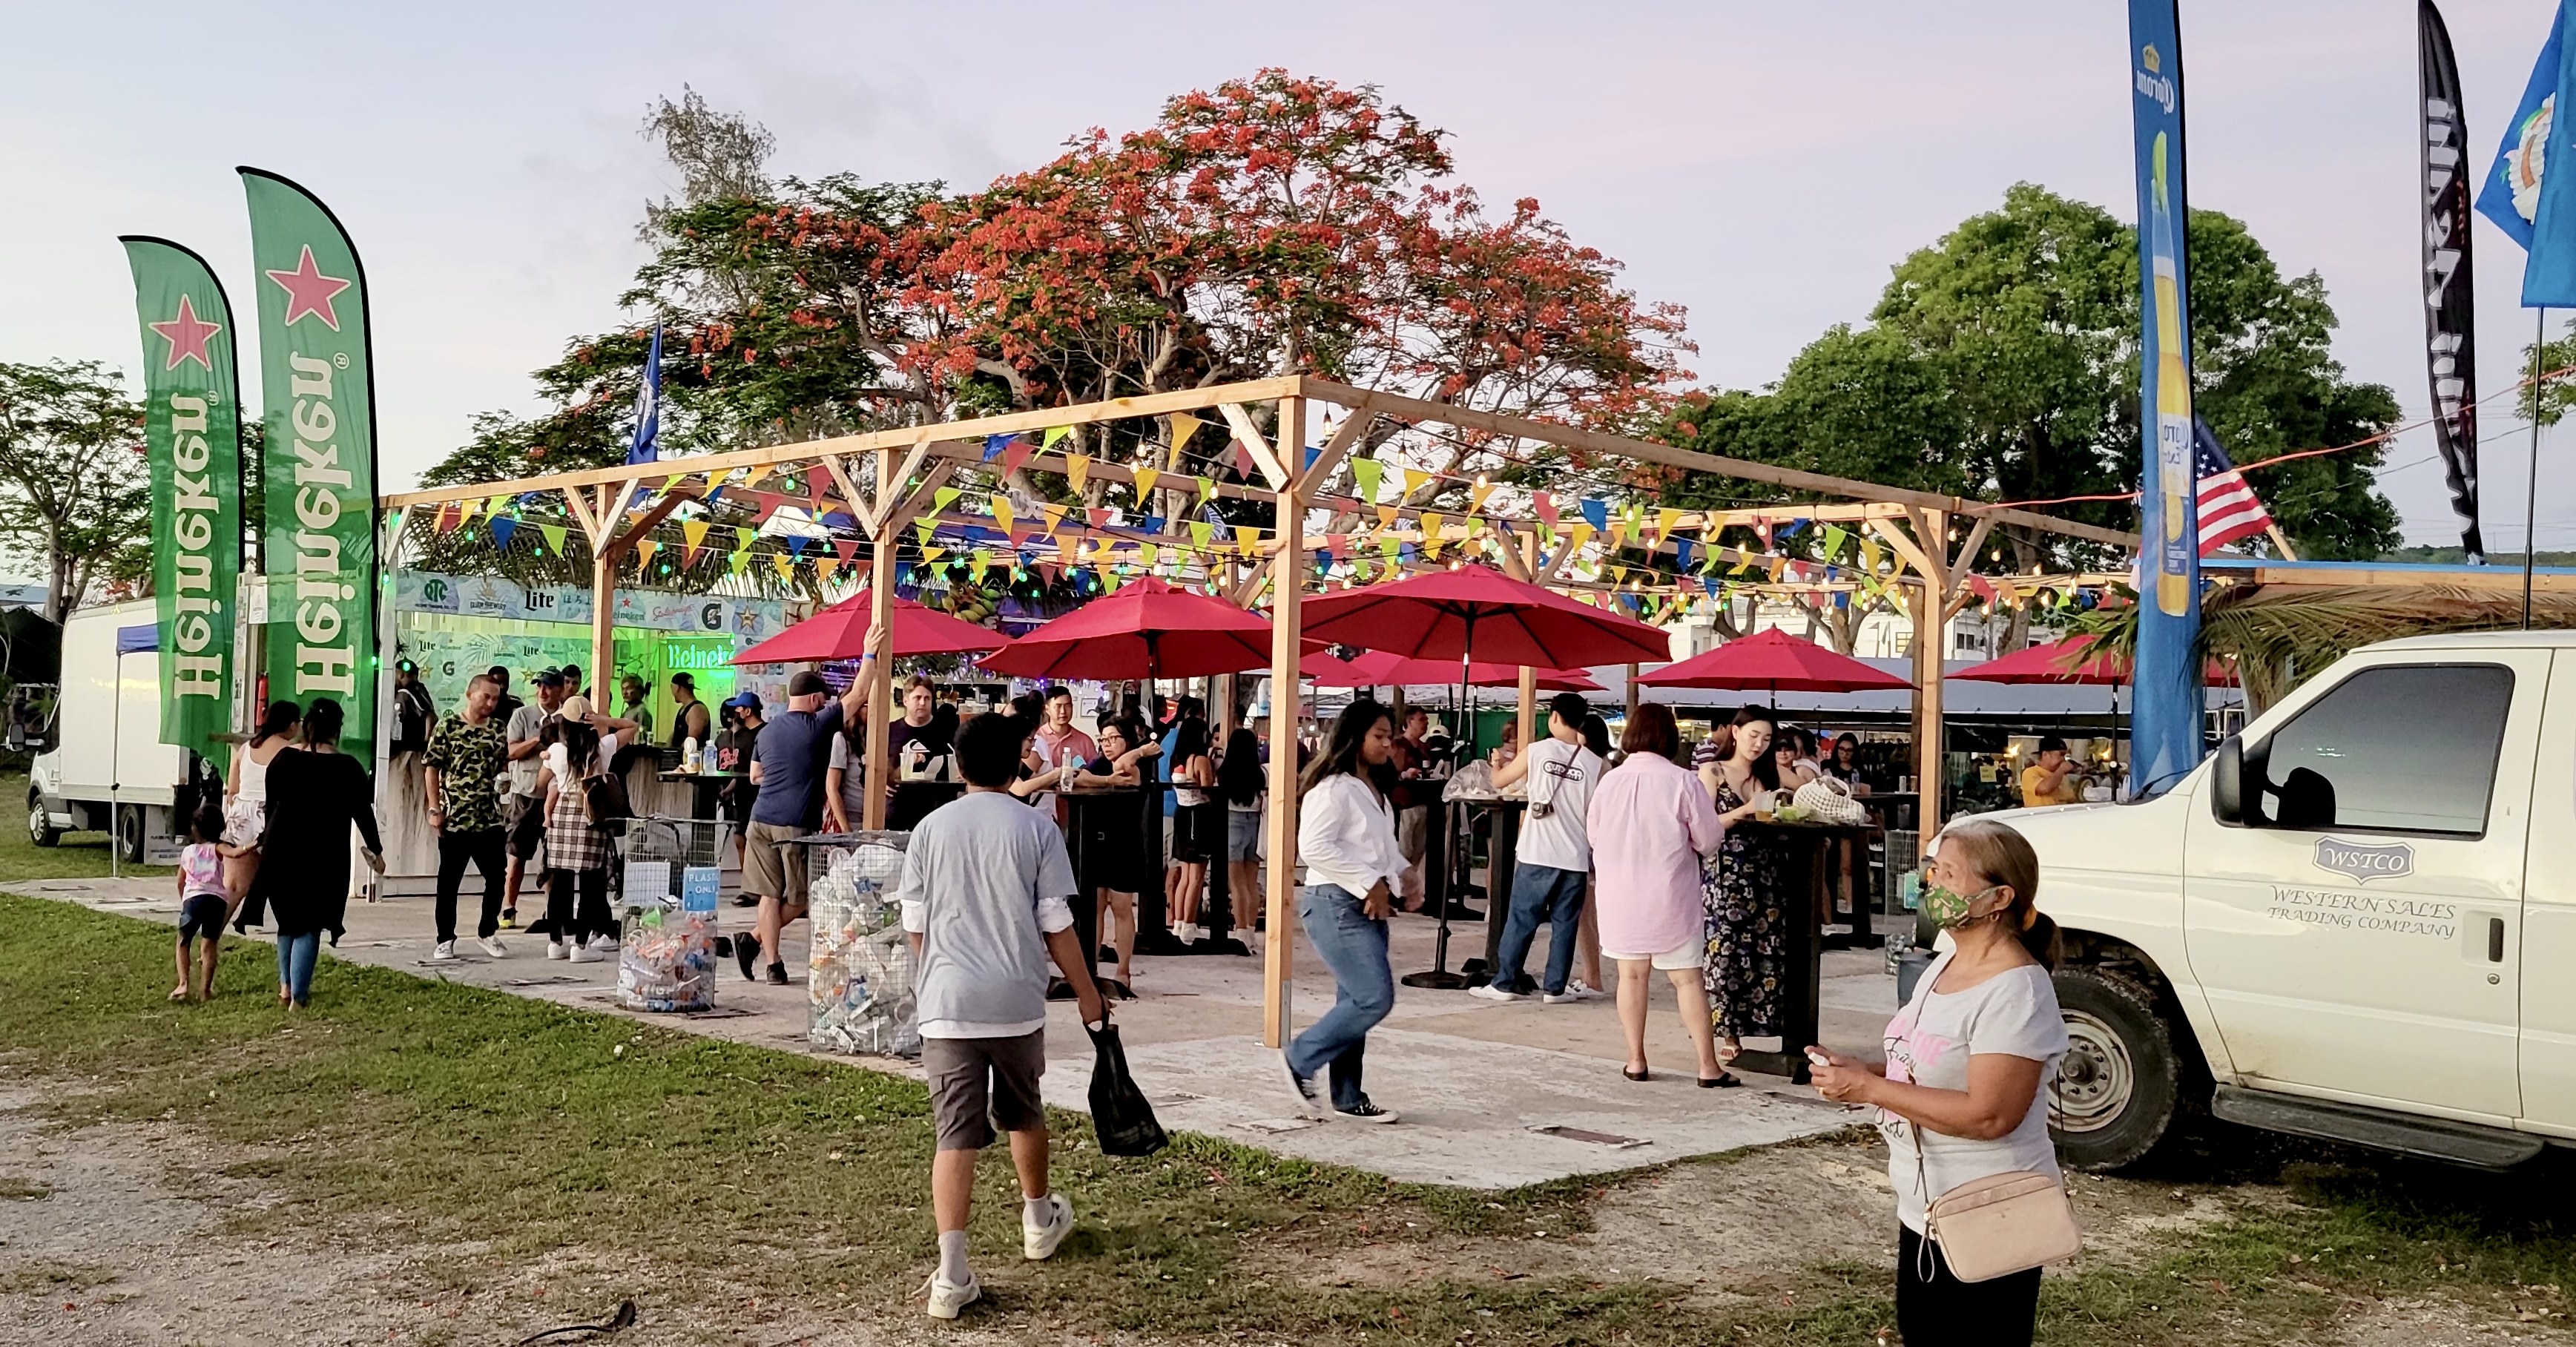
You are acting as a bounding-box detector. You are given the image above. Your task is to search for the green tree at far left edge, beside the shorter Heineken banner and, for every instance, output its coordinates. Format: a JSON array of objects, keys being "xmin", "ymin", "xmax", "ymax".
[{"xmin": 0, "ymin": 360, "xmax": 152, "ymax": 623}]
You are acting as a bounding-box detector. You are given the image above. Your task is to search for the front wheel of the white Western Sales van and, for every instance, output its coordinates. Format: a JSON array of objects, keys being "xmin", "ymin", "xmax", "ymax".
[{"xmin": 2043, "ymin": 969, "xmax": 2182, "ymax": 1169}]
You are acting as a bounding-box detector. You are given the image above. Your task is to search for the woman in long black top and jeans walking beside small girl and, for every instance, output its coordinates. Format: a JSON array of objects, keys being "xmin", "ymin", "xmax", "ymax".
[{"xmin": 255, "ymin": 698, "xmax": 383, "ymax": 1010}]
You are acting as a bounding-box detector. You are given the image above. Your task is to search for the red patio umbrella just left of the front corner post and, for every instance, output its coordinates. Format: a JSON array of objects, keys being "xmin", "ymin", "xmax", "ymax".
[{"xmin": 984, "ymin": 577, "xmax": 1270, "ymax": 680}]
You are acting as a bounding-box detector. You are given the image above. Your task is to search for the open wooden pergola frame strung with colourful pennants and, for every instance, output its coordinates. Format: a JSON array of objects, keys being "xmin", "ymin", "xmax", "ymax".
[{"xmin": 383, "ymin": 376, "xmax": 2138, "ymax": 1046}]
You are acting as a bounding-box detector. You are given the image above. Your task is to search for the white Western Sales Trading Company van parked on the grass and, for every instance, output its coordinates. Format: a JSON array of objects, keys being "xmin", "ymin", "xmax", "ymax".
[{"xmin": 2002, "ymin": 631, "xmax": 2576, "ymax": 1169}]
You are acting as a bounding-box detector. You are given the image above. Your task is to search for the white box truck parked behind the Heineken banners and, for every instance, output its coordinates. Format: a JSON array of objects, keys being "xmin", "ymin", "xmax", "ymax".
[{"xmin": 26, "ymin": 600, "xmax": 191, "ymax": 866}]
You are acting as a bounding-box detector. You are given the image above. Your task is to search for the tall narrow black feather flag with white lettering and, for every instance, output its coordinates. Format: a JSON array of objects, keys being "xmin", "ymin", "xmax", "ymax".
[{"xmin": 2417, "ymin": 0, "xmax": 2486, "ymax": 561}]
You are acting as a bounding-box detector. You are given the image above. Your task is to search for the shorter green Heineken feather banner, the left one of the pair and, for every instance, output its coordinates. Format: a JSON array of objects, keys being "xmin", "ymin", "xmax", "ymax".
[{"xmin": 121, "ymin": 237, "xmax": 242, "ymax": 760}]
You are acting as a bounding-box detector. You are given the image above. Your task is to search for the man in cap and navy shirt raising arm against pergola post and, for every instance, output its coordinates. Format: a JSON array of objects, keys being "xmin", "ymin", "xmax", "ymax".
[{"xmin": 734, "ymin": 659, "xmax": 878, "ymax": 987}]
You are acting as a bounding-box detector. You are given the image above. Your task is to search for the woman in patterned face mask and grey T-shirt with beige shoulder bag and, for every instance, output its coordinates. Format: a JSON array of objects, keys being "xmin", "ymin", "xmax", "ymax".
[{"xmin": 1808, "ymin": 819, "xmax": 2066, "ymax": 1345}]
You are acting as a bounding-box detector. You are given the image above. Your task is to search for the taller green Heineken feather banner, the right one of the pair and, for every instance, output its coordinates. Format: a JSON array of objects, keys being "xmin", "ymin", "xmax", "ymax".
[{"xmin": 242, "ymin": 168, "xmax": 376, "ymax": 760}]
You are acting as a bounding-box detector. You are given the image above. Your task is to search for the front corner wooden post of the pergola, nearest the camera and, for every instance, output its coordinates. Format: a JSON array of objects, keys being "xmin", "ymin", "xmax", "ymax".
[{"xmin": 1262, "ymin": 397, "xmax": 1306, "ymax": 1048}]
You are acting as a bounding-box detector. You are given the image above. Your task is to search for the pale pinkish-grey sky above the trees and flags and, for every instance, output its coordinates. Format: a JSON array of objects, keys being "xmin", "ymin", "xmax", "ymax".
[{"xmin": 0, "ymin": 0, "xmax": 2576, "ymax": 551}]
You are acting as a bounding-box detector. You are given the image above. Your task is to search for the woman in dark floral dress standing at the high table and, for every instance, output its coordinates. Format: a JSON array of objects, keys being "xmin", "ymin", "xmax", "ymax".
[{"xmin": 1700, "ymin": 705, "xmax": 1793, "ymax": 1081}]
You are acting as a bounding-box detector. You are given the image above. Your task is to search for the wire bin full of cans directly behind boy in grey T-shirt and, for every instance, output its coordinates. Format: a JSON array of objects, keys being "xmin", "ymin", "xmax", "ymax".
[{"xmin": 796, "ymin": 832, "xmax": 922, "ymax": 1056}]
